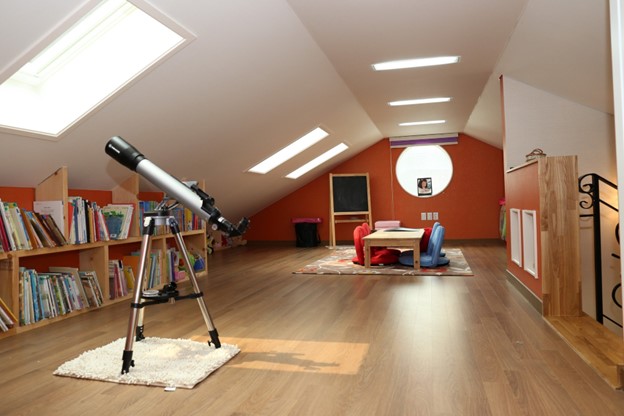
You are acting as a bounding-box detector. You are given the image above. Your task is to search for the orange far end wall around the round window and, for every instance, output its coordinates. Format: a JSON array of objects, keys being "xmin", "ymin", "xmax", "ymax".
[{"xmin": 245, "ymin": 134, "xmax": 504, "ymax": 241}]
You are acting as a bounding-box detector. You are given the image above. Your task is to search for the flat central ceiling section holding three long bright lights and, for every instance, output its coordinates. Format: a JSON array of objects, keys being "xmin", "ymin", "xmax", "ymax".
[{"xmin": 288, "ymin": 0, "xmax": 527, "ymax": 137}]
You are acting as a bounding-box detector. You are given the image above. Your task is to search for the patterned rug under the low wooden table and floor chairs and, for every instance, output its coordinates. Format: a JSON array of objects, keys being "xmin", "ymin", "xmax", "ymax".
[{"xmin": 293, "ymin": 247, "xmax": 473, "ymax": 276}]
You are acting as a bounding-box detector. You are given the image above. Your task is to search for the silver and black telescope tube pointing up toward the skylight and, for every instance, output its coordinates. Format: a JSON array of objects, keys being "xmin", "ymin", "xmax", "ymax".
[{"xmin": 105, "ymin": 136, "xmax": 249, "ymax": 237}]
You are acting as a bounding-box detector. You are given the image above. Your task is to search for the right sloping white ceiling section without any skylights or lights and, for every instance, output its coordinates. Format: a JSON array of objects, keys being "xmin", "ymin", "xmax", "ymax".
[{"xmin": 465, "ymin": 0, "xmax": 613, "ymax": 147}]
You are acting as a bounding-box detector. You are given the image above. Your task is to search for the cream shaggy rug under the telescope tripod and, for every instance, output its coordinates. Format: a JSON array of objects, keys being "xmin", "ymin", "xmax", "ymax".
[{"xmin": 54, "ymin": 337, "xmax": 240, "ymax": 389}]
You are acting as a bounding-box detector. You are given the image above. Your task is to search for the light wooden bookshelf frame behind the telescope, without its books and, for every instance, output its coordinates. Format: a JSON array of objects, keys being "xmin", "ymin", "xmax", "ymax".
[{"xmin": 0, "ymin": 167, "xmax": 208, "ymax": 338}]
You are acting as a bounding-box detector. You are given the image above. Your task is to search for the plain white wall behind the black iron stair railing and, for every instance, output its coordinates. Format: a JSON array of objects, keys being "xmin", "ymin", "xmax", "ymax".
[{"xmin": 503, "ymin": 76, "xmax": 621, "ymax": 331}]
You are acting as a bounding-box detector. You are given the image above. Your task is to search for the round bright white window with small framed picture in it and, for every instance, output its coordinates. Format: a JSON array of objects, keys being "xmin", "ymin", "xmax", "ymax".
[{"xmin": 396, "ymin": 145, "xmax": 453, "ymax": 198}]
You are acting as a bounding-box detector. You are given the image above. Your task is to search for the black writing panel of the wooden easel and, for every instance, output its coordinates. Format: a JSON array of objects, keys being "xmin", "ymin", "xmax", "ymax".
[{"xmin": 332, "ymin": 174, "xmax": 369, "ymax": 213}]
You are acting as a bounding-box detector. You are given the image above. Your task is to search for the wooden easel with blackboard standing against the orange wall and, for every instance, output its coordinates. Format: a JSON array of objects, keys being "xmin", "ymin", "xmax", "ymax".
[{"xmin": 329, "ymin": 173, "xmax": 373, "ymax": 247}]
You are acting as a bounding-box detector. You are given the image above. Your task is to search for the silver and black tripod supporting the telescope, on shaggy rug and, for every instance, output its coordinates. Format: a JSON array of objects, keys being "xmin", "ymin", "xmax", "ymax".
[{"xmin": 121, "ymin": 210, "xmax": 221, "ymax": 374}]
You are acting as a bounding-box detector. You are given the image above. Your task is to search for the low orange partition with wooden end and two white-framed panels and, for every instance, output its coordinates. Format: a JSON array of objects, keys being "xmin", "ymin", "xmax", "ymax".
[{"xmin": 505, "ymin": 156, "xmax": 582, "ymax": 316}]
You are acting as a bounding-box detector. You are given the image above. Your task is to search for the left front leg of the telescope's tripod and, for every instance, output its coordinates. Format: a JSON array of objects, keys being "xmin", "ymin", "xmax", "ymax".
[{"xmin": 121, "ymin": 217, "xmax": 154, "ymax": 374}]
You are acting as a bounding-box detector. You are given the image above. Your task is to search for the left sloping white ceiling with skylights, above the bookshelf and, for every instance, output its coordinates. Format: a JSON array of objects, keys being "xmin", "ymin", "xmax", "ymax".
[{"xmin": 0, "ymin": 0, "xmax": 382, "ymax": 224}]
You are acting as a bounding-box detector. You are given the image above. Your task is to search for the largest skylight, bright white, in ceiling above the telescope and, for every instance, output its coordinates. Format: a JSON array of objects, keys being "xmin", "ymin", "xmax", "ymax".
[{"xmin": 0, "ymin": 0, "xmax": 192, "ymax": 139}]
